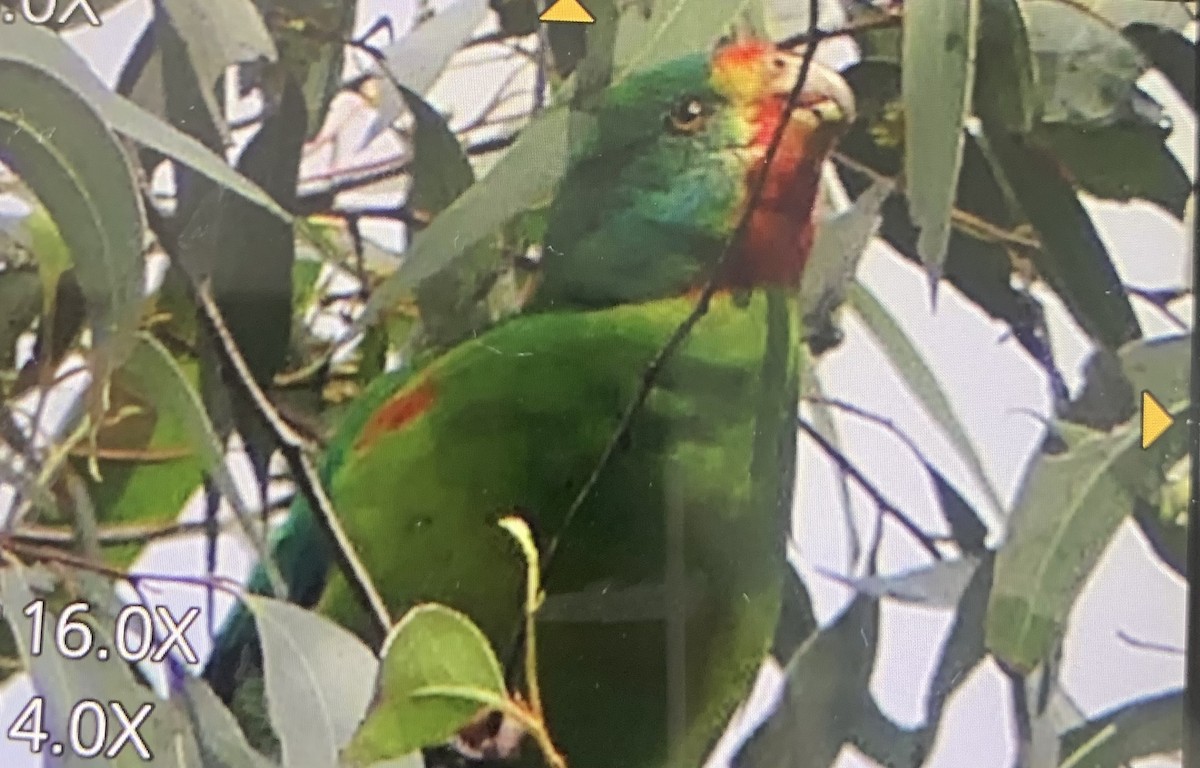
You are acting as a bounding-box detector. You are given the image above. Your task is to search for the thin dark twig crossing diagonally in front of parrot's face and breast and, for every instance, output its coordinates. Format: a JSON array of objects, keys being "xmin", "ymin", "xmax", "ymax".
[{"xmin": 541, "ymin": 6, "xmax": 820, "ymax": 584}]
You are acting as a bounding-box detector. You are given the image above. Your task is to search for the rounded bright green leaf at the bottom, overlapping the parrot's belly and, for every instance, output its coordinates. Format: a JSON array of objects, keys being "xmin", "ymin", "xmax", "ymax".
[{"xmin": 344, "ymin": 605, "xmax": 508, "ymax": 764}]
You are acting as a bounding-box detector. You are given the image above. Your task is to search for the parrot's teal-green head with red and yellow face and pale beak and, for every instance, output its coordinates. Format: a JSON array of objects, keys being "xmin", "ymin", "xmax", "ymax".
[{"xmin": 534, "ymin": 40, "xmax": 854, "ymax": 307}]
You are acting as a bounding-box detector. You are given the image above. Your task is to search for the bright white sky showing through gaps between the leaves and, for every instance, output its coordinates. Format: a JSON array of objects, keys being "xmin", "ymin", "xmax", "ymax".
[{"xmin": 0, "ymin": 0, "xmax": 1196, "ymax": 768}]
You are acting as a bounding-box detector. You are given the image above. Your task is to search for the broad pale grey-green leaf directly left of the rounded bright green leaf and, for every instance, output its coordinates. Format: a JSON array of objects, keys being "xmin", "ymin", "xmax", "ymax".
[{"xmin": 246, "ymin": 595, "xmax": 384, "ymax": 768}]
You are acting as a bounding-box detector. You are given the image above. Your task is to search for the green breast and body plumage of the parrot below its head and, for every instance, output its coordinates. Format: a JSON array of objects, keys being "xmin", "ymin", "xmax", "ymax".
[{"xmin": 320, "ymin": 294, "xmax": 798, "ymax": 768}]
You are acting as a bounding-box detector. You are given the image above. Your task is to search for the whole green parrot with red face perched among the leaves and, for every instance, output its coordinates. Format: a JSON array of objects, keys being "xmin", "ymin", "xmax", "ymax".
[{"xmin": 205, "ymin": 40, "xmax": 854, "ymax": 768}]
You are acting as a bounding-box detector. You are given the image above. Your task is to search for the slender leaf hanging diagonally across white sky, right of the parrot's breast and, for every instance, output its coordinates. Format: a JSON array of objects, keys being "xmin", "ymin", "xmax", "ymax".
[{"xmin": 848, "ymin": 283, "xmax": 1004, "ymax": 528}]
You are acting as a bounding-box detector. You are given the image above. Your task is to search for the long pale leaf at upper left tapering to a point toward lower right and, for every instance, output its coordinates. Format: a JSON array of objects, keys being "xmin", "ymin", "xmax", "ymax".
[{"xmin": 0, "ymin": 24, "xmax": 292, "ymax": 222}]
